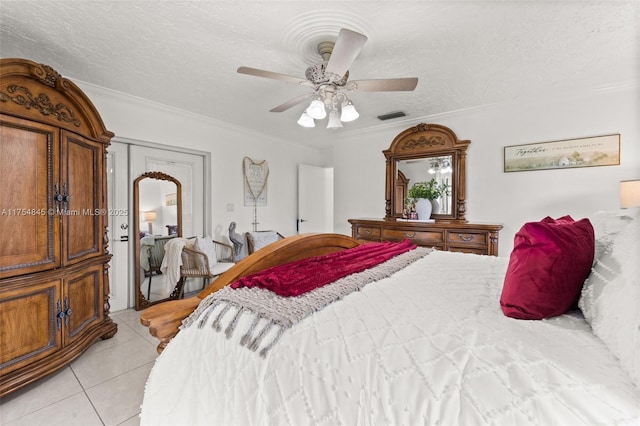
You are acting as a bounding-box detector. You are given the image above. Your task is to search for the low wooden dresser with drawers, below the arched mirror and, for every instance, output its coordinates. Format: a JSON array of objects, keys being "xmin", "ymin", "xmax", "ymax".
[{"xmin": 349, "ymin": 219, "xmax": 502, "ymax": 256}]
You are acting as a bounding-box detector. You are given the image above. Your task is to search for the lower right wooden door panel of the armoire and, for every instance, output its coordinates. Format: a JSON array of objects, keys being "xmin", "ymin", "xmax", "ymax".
[{"xmin": 63, "ymin": 265, "xmax": 103, "ymax": 345}]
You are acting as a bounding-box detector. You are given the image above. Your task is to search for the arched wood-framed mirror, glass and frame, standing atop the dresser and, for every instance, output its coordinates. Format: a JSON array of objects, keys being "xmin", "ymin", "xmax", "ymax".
[{"xmin": 383, "ymin": 123, "xmax": 471, "ymax": 222}]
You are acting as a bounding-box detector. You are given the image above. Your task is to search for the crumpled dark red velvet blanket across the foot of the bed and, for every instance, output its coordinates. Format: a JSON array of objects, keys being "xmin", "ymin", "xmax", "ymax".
[{"xmin": 231, "ymin": 240, "xmax": 416, "ymax": 296}]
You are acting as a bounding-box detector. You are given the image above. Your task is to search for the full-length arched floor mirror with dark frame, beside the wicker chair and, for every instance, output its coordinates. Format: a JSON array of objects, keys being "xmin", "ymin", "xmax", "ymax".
[{"xmin": 133, "ymin": 172, "xmax": 182, "ymax": 310}]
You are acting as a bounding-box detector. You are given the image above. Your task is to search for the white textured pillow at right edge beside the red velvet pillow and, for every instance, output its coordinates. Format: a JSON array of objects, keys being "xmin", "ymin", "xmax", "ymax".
[{"xmin": 578, "ymin": 212, "xmax": 640, "ymax": 387}]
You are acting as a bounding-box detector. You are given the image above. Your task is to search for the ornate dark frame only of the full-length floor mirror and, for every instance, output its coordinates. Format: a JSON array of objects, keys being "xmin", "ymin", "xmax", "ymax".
[{"xmin": 133, "ymin": 172, "xmax": 182, "ymax": 310}]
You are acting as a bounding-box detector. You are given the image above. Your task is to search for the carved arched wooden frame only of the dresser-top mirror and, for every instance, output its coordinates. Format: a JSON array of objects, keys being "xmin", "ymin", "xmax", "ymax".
[{"xmin": 382, "ymin": 123, "xmax": 471, "ymax": 222}]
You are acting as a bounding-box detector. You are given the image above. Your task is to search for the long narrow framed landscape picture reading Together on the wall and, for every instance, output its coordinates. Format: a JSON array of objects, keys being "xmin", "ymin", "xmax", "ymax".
[{"xmin": 504, "ymin": 133, "xmax": 620, "ymax": 172}]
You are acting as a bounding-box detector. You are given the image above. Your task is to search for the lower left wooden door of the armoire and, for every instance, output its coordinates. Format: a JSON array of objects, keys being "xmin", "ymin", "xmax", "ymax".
[{"xmin": 0, "ymin": 280, "xmax": 62, "ymax": 376}]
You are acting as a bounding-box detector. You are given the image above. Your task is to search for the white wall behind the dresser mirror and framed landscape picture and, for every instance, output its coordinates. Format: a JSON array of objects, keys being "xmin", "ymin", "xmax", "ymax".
[{"xmin": 333, "ymin": 83, "xmax": 640, "ymax": 256}]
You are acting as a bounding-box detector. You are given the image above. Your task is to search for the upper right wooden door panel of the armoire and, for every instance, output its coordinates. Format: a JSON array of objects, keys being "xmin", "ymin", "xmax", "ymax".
[{"xmin": 61, "ymin": 131, "xmax": 106, "ymax": 265}]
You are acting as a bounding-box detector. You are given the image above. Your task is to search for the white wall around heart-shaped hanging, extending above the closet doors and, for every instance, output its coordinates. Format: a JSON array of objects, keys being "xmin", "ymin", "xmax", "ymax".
[{"xmin": 78, "ymin": 82, "xmax": 330, "ymax": 241}]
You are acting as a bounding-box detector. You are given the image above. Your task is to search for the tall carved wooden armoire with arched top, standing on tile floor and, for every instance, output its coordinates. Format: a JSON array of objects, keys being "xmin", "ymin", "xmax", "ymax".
[{"xmin": 0, "ymin": 58, "xmax": 117, "ymax": 396}]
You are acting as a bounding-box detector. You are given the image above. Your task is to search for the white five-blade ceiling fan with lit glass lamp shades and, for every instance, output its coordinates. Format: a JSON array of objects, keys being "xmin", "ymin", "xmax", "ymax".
[{"xmin": 238, "ymin": 28, "xmax": 418, "ymax": 129}]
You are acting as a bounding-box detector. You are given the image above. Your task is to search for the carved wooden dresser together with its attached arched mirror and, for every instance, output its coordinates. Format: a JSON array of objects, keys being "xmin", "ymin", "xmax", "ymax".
[{"xmin": 349, "ymin": 123, "xmax": 502, "ymax": 256}]
